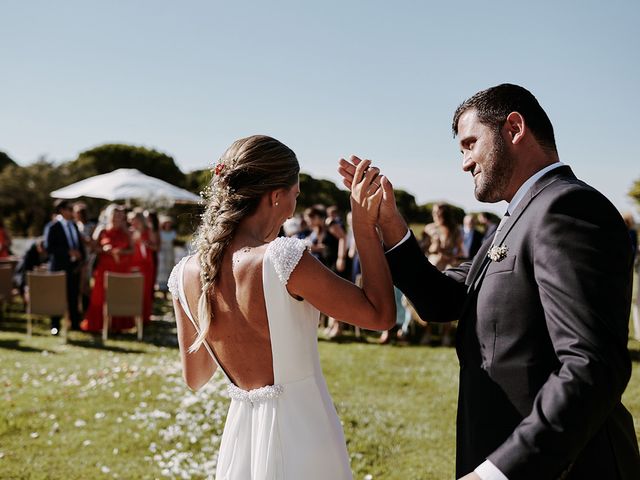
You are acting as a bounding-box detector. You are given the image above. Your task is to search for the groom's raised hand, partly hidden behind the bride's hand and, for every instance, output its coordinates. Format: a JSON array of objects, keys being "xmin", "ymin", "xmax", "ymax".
[{"xmin": 338, "ymin": 155, "xmax": 408, "ymax": 248}]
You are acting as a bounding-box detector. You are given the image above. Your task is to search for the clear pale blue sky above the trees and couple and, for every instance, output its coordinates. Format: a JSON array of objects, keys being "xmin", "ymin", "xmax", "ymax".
[{"xmin": 0, "ymin": 0, "xmax": 640, "ymax": 212}]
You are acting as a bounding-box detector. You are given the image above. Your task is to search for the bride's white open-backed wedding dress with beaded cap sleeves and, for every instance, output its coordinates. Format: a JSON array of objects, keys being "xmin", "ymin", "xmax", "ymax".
[{"xmin": 169, "ymin": 237, "xmax": 352, "ymax": 480}]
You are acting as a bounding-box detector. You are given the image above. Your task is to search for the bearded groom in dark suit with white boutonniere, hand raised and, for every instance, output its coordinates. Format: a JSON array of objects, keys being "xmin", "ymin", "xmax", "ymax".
[{"xmin": 340, "ymin": 84, "xmax": 640, "ymax": 480}]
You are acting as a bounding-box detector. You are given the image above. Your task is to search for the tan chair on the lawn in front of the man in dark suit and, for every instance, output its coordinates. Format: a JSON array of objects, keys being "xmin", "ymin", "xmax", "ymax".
[{"xmin": 27, "ymin": 271, "xmax": 69, "ymax": 341}]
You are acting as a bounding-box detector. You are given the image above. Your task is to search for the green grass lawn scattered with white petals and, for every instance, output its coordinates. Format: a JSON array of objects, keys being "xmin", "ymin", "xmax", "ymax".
[{"xmin": 0, "ymin": 310, "xmax": 640, "ymax": 480}]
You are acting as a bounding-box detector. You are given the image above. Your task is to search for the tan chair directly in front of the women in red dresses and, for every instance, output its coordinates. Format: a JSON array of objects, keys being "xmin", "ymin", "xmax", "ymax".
[{"xmin": 102, "ymin": 272, "xmax": 144, "ymax": 341}]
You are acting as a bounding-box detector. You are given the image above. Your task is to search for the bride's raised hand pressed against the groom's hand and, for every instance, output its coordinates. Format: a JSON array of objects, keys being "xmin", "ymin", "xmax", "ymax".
[{"xmin": 351, "ymin": 160, "xmax": 383, "ymax": 225}]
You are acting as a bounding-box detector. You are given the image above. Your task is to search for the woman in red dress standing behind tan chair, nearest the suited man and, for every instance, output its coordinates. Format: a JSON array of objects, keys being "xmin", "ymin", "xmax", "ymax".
[{"xmin": 80, "ymin": 204, "xmax": 135, "ymax": 332}]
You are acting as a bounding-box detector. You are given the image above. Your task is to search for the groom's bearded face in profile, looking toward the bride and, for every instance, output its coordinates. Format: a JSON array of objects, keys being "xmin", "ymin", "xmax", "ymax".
[{"xmin": 458, "ymin": 110, "xmax": 514, "ymax": 203}]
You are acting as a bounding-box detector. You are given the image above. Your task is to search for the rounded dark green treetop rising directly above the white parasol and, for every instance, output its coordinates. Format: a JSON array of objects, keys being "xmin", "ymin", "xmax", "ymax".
[{"xmin": 65, "ymin": 144, "xmax": 185, "ymax": 187}]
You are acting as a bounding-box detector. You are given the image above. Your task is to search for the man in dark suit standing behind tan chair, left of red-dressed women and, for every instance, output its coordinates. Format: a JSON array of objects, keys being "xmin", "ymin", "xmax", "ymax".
[{"xmin": 45, "ymin": 200, "xmax": 85, "ymax": 335}]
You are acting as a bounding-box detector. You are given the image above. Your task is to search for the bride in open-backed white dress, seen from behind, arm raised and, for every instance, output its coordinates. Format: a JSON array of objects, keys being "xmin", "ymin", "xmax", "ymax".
[{"xmin": 169, "ymin": 135, "xmax": 395, "ymax": 480}]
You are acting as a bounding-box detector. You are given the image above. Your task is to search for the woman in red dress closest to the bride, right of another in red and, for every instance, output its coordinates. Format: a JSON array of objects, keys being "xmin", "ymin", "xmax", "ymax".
[{"xmin": 129, "ymin": 212, "xmax": 155, "ymax": 325}]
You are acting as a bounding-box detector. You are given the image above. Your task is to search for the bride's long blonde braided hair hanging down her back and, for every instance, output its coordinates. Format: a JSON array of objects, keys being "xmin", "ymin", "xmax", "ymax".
[{"xmin": 189, "ymin": 135, "xmax": 300, "ymax": 352}]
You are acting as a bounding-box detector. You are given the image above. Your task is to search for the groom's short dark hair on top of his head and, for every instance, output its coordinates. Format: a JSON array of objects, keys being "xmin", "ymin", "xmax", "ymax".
[{"xmin": 452, "ymin": 83, "xmax": 557, "ymax": 152}]
